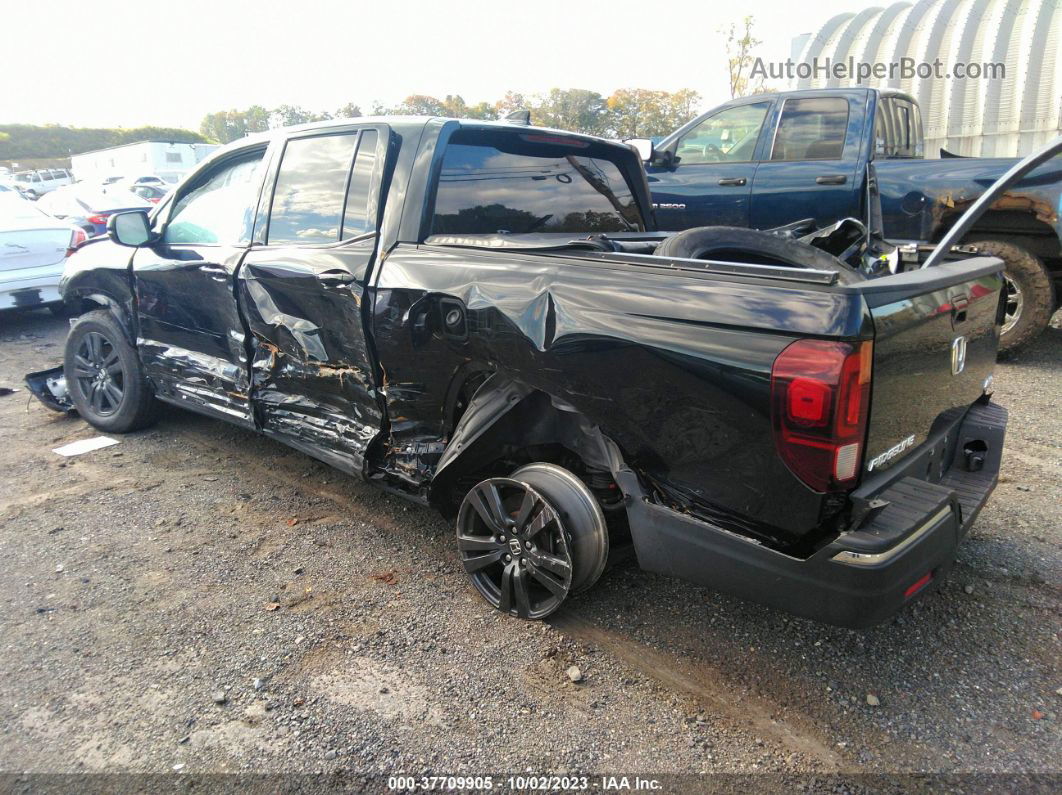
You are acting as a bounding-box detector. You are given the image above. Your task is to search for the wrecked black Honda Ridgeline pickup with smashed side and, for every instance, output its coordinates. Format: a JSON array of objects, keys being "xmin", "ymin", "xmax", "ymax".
[{"xmin": 28, "ymin": 118, "xmax": 1007, "ymax": 626}]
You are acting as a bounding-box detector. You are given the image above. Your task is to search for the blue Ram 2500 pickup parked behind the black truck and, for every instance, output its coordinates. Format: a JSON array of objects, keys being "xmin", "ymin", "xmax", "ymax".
[{"xmin": 638, "ymin": 88, "xmax": 1062, "ymax": 350}]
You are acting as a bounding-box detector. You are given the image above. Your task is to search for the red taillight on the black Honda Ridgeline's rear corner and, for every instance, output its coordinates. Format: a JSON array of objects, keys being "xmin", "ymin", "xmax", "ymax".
[{"xmin": 771, "ymin": 340, "xmax": 874, "ymax": 491}]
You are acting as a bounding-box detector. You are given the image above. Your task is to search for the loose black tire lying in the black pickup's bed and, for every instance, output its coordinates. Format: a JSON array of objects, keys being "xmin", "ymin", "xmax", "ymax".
[{"xmin": 654, "ymin": 226, "xmax": 863, "ymax": 284}]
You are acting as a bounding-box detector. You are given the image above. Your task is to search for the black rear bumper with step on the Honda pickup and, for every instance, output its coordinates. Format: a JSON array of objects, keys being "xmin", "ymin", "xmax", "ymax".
[{"xmin": 629, "ymin": 403, "xmax": 1007, "ymax": 628}]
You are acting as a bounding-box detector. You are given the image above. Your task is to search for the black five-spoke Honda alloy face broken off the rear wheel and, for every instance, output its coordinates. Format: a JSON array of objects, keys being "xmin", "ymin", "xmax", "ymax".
[{"xmin": 457, "ymin": 478, "xmax": 572, "ymax": 619}]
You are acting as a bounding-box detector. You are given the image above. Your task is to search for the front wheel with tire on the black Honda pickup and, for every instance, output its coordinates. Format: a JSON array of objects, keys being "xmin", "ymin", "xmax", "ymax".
[{"xmin": 63, "ymin": 310, "xmax": 159, "ymax": 433}]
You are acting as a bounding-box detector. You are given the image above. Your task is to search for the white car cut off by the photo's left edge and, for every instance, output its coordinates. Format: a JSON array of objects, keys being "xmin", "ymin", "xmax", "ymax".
[{"xmin": 0, "ymin": 190, "xmax": 88, "ymax": 309}]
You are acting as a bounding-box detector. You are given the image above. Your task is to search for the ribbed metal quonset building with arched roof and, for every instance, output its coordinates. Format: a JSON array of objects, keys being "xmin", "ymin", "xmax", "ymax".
[{"xmin": 791, "ymin": 0, "xmax": 1062, "ymax": 157}]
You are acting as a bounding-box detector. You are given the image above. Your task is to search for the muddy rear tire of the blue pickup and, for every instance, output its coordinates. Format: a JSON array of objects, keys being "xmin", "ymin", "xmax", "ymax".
[{"xmin": 964, "ymin": 240, "xmax": 1055, "ymax": 353}]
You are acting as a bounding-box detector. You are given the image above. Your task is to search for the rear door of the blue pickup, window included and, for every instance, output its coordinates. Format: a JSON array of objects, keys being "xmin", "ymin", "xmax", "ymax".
[{"xmin": 751, "ymin": 96, "xmax": 863, "ymax": 229}]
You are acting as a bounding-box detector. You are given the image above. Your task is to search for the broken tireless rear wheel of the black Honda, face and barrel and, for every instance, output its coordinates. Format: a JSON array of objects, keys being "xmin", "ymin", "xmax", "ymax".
[{"xmin": 457, "ymin": 464, "xmax": 609, "ymax": 619}]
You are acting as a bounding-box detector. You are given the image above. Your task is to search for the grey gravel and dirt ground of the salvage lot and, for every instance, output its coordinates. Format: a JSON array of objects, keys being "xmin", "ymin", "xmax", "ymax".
[{"xmin": 0, "ymin": 312, "xmax": 1062, "ymax": 780}]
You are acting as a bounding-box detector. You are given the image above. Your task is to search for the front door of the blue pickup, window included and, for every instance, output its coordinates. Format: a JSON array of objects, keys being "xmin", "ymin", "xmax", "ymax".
[{"xmin": 646, "ymin": 101, "xmax": 771, "ymax": 231}]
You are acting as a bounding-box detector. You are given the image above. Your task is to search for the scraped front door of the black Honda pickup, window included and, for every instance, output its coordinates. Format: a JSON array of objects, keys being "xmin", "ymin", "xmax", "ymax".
[{"xmin": 133, "ymin": 146, "xmax": 266, "ymax": 427}]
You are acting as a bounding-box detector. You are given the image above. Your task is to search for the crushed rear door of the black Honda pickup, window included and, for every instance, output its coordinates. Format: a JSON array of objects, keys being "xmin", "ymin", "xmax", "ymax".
[{"xmin": 238, "ymin": 126, "xmax": 389, "ymax": 474}]
